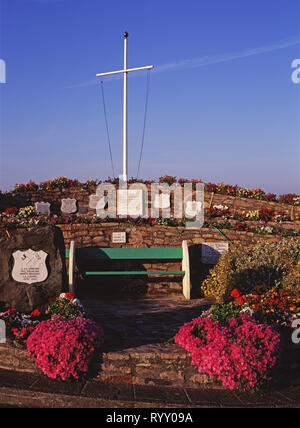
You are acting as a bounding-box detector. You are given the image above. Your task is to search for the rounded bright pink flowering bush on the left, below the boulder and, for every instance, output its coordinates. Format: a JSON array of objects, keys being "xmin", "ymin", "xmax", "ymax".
[{"xmin": 26, "ymin": 317, "xmax": 103, "ymax": 380}]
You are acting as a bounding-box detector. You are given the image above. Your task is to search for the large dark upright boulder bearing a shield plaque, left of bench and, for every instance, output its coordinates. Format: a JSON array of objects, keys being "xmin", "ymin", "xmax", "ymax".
[{"xmin": 0, "ymin": 226, "xmax": 67, "ymax": 312}]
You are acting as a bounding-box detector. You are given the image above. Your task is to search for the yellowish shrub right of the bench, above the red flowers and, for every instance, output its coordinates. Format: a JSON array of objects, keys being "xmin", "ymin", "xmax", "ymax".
[{"xmin": 201, "ymin": 238, "xmax": 300, "ymax": 300}]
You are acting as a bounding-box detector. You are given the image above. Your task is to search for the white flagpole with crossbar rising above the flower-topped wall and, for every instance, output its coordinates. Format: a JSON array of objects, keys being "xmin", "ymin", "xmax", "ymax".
[{"xmin": 96, "ymin": 33, "xmax": 154, "ymax": 181}]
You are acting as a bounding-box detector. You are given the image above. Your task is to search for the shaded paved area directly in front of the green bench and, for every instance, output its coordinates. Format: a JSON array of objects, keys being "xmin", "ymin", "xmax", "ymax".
[{"xmin": 82, "ymin": 295, "xmax": 213, "ymax": 352}]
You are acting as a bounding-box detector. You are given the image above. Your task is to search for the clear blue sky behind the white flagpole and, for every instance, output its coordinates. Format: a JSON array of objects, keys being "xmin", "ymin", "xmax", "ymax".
[{"xmin": 0, "ymin": 0, "xmax": 300, "ymax": 193}]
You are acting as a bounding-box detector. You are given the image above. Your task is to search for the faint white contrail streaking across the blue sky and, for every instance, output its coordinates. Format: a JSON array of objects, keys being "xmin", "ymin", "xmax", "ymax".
[{"xmin": 69, "ymin": 37, "xmax": 300, "ymax": 88}]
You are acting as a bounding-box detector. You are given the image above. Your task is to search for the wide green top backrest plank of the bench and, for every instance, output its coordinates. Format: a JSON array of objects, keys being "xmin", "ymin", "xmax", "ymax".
[{"xmin": 66, "ymin": 247, "xmax": 183, "ymax": 260}]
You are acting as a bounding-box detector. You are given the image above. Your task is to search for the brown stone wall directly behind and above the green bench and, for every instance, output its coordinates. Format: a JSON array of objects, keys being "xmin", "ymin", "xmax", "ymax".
[{"xmin": 58, "ymin": 223, "xmax": 300, "ymax": 297}]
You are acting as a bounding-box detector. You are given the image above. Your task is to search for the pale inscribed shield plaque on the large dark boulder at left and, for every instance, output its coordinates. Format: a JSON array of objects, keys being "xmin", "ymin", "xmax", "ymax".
[{"xmin": 12, "ymin": 249, "xmax": 48, "ymax": 284}]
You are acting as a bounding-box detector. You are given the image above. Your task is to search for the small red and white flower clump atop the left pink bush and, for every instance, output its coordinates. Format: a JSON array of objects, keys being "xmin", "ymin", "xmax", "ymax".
[{"xmin": 46, "ymin": 293, "xmax": 84, "ymax": 318}]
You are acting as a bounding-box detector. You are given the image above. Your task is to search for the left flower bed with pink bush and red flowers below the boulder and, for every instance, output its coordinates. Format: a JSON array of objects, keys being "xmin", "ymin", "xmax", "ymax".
[{"xmin": 0, "ymin": 293, "xmax": 104, "ymax": 380}]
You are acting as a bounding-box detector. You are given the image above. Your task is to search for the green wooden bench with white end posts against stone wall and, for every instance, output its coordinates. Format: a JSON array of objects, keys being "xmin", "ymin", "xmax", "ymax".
[{"xmin": 66, "ymin": 241, "xmax": 191, "ymax": 299}]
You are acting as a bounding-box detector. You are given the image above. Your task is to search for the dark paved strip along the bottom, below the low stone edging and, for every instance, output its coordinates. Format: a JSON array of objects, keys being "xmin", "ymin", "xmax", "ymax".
[{"xmin": 0, "ymin": 370, "xmax": 300, "ymax": 409}]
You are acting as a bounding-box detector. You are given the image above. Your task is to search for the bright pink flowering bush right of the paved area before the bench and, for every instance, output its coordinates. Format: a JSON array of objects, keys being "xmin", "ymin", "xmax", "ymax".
[{"xmin": 175, "ymin": 315, "xmax": 280, "ymax": 391}]
